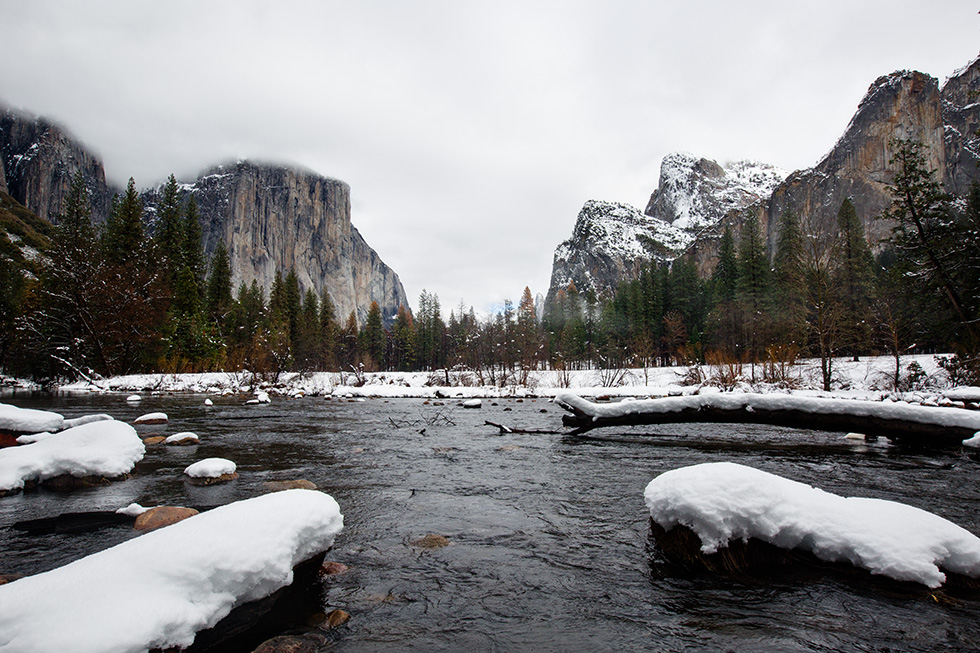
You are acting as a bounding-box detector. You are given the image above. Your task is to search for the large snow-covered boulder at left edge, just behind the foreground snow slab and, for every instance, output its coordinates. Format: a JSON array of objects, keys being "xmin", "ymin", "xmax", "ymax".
[{"xmin": 0, "ymin": 420, "xmax": 146, "ymax": 493}]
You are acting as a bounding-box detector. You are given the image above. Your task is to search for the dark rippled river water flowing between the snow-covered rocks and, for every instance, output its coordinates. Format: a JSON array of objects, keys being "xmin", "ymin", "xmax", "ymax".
[{"xmin": 0, "ymin": 394, "xmax": 980, "ymax": 651}]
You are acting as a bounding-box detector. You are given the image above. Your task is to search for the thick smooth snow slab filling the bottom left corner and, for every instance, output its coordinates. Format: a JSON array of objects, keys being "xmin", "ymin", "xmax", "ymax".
[{"xmin": 0, "ymin": 490, "xmax": 343, "ymax": 653}]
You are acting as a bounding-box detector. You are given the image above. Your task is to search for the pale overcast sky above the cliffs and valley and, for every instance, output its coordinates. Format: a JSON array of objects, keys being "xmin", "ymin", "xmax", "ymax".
[{"xmin": 0, "ymin": 0, "xmax": 980, "ymax": 315}]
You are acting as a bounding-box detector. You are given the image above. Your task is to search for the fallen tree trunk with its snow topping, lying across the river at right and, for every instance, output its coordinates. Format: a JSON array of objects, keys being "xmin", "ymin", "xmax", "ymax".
[{"xmin": 555, "ymin": 393, "xmax": 980, "ymax": 447}]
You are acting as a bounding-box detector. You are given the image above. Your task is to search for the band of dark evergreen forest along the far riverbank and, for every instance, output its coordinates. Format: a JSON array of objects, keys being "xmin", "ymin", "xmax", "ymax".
[{"xmin": 0, "ymin": 141, "xmax": 980, "ymax": 389}]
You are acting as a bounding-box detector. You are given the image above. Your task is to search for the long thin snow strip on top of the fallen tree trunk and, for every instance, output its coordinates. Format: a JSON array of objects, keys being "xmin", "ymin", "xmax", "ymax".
[{"xmin": 555, "ymin": 392, "xmax": 980, "ymax": 430}]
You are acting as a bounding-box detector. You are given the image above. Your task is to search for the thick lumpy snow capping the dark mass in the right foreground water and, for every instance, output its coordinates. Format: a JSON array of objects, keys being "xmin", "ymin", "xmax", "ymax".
[{"xmin": 644, "ymin": 462, "xmax": 980, "ymax": 588}]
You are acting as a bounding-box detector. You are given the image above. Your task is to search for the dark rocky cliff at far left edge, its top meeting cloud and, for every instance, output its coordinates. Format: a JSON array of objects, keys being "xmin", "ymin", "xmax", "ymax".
[{"xmin": 0, "ymin": 105, "xmax": 114, "ymax": 223}]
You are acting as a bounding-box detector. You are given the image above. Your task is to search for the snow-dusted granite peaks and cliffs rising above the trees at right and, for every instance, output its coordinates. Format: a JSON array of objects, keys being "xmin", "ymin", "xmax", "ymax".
[{"xmin": 549, "ymin": 58, "xmax": 980, "ymax": 299}]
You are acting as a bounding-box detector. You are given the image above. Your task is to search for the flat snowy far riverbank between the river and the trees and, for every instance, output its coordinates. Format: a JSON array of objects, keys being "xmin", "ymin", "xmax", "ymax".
[{"xmin": 8, "ymin": 355, "xmax": 968, "ymax": 404}]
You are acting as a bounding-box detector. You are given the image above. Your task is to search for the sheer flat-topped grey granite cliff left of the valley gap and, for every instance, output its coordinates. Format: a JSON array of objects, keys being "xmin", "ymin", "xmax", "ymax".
[{"xmin": 185, "ymin": 161, "xmax": 409, "ymax": 324}]
